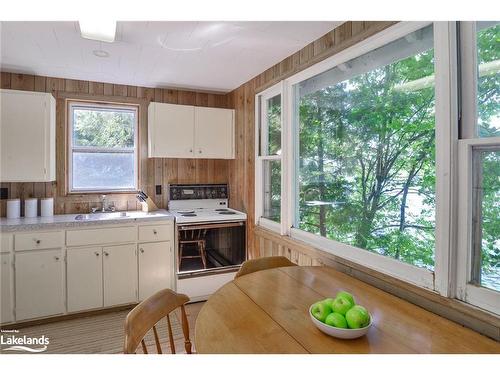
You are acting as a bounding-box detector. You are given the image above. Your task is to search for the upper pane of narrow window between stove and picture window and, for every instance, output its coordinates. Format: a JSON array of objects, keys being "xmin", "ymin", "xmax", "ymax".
[{"xmin": 261, "ymin": 95, "xmax": 281, "ymax": 155}]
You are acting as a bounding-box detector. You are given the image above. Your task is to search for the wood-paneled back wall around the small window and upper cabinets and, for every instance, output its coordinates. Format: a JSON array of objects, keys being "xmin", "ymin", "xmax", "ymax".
[{"xmin": 0, "ymin": 72, "xmax": 233, "ymax": 216}]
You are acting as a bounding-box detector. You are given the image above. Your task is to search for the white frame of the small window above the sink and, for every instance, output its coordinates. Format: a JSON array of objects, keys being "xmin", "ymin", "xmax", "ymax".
[{"xmin": 67, "ymin": 100, "xmax": 139, "ymax": 194}]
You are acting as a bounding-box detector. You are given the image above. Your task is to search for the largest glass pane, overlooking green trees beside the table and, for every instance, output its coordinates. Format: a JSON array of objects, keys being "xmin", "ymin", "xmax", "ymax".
[{"xmin": 295, "ymin": 26, "xmax": 435, "ymax": 269}]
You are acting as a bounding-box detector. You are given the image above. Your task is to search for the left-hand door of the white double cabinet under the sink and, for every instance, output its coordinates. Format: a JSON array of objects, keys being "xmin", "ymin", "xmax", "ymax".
[{"xmin": 67, "ymin": 247, "xmax": 103, "ymax": 312}]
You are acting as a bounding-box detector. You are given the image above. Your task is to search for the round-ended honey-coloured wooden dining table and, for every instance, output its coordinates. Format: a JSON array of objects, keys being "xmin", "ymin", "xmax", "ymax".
[{"xmin": 194, "ymin": 266, "xmax": 500, "ymax": 354}]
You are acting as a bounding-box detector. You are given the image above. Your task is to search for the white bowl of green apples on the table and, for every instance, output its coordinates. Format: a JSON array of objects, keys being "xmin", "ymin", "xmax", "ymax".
[{"xmin": 309, "ymin": 291, "xmax": 373, "ymax": 339}]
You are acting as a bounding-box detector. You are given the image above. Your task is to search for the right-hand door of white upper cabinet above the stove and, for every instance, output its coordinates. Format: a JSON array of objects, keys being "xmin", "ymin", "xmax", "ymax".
[{"xmin": 194, "ymin": 107, "xmax": 234, "ymax": 159}]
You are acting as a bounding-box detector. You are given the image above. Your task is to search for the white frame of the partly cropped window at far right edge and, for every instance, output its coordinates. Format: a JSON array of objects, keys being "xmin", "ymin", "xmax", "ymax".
[{"xmin": 455, "ymin": 22, "xmax": 500, "ymax": 315}]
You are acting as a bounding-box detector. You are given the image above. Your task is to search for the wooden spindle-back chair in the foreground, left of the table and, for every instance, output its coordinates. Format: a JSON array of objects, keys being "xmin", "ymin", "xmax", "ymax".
[{"xmin": 123, "ymin": 289, "xmax": 191, "ymax": 354}]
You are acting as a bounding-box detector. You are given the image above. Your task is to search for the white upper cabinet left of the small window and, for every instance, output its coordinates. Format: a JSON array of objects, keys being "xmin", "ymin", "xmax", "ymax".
[{"xmin": 0, "ymin": 90, "xmax": 56, "ymax": 182}]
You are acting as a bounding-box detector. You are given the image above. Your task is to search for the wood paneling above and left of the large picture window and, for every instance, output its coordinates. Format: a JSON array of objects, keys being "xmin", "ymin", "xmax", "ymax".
[{"xmin": 229, "ymin": 21, "xmax": 395, "ymax": 257}]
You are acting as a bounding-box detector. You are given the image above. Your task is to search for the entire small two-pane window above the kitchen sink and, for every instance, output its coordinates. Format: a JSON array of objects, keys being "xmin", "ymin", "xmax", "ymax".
[{"xmin": 68, "ymin": 102, "xmax": 138, "ymax": 192}]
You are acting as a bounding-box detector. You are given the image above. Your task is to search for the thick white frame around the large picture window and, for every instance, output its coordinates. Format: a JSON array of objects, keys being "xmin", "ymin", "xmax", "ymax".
[{"xmin": 255, "ymin": 22, "xmax": 458, "ymax": 296}]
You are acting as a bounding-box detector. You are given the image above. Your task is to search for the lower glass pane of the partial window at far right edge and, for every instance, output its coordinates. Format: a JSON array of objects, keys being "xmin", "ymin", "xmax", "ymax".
[{"xmin": 473, "ymin": 151, "xmax": 500, "ymax": 291}]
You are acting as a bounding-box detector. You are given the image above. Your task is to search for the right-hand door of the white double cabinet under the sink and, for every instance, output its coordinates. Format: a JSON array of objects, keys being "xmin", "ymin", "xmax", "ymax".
[{"xmin": 102, "ymin": 244, "xmax": 137, "ymax": 306}]
